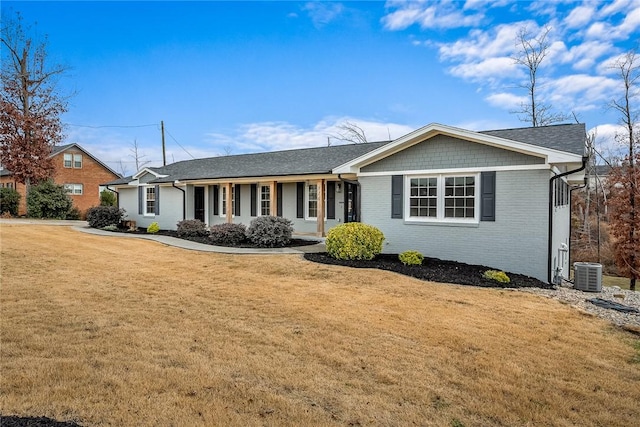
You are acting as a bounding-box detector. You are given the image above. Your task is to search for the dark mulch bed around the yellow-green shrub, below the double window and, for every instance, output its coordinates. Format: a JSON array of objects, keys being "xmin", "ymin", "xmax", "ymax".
[{"xmin": 304, "ymin": 252, "xmax": 553, "ymax": 289}]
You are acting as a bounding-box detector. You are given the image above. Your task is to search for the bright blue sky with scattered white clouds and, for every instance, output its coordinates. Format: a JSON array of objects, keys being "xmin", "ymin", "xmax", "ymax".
[{"xmin": 2, "ymin": 0, "xmax": 640, "ymax": 173}]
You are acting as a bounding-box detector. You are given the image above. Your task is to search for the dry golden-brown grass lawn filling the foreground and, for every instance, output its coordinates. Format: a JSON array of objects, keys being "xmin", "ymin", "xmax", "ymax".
[{"xmin": 0, "ymin": 224, "xmax": 640, "ymax": 426}]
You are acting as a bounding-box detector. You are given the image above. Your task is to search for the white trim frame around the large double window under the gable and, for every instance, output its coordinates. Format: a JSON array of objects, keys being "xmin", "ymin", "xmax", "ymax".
[{"xmin": 404, "ymin": 173, "xmax": 480, "ymax": 224}]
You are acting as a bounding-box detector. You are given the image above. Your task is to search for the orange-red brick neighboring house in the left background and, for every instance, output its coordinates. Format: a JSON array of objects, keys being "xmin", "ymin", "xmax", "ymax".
[{"xmin": 0, "ymin": 144, "xmax": 120, "ymax": 218}]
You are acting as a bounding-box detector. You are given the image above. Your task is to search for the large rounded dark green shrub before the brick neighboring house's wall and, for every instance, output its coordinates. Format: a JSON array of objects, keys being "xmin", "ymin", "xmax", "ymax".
[{"xmin": 27, "ymin": 180, "xmax": 73, "ymax": 219}]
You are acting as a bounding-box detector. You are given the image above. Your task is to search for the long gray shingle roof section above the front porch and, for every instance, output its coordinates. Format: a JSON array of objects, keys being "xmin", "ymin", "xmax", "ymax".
[{"xmin": 146, "ymin": 142, "xmax": 388, "ymax": 185}]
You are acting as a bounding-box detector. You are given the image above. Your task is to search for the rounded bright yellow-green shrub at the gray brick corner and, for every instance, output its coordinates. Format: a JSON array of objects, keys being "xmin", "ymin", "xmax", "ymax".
[{"xmin": 325, "ymin": 222, "xmax": 384, "ymax": 260}]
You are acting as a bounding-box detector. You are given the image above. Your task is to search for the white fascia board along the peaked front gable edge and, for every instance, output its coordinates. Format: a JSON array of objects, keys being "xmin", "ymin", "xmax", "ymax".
[{"xmin": 333, "ymin": 123, "xmax": 582, "ymax": 174}]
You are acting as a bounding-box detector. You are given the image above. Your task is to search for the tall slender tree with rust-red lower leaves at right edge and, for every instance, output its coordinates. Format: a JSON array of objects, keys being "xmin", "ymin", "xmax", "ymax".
[{"xmin": 609, "ymin": 50, "xmax": 640, "ymax": 290}]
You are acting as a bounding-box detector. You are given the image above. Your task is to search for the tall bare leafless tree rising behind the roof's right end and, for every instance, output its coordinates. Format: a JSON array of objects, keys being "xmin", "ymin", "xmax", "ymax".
[{"xmin": 511, "ymin": 26, "xmax": 569, "ymax": 127}]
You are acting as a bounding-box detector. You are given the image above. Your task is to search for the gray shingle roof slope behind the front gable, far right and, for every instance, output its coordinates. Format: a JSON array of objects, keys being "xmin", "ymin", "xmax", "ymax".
[{"xmin": 479, "ymin": 123, "xmax": 587, "ymax": 156}]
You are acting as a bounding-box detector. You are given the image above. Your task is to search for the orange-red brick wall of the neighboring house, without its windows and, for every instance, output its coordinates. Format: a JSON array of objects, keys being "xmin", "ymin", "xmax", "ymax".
[{"xmin": 0, "ymin": 147, "xmax": 118, "ymax": 218}]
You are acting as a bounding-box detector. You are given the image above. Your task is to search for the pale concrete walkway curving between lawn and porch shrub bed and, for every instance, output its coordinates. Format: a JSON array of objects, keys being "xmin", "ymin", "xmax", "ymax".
[{"xmin": 0, "ymin": 218, "xmax": 325, "ymax": 255}]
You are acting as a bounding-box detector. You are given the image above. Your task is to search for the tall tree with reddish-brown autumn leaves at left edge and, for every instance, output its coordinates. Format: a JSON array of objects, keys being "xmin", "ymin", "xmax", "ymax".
[{"xmin": 0, "ymin": 13, "xmax": 67, "ymax": 185}]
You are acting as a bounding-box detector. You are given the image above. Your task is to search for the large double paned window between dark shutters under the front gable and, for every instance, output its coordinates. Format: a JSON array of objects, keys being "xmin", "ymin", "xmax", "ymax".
[{"xmin": 408, "ymin": 175, "xmax": 479, "ymax": 221}]
